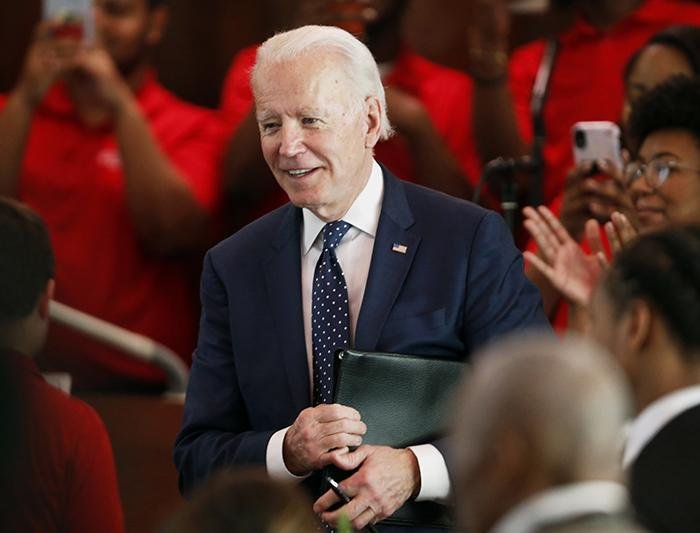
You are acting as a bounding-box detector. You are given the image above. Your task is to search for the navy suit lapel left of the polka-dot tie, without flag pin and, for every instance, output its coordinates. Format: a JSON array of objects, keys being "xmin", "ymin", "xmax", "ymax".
[{"xmin": 263, "ymin": 205, "xmax": 311, "ymax": 412}]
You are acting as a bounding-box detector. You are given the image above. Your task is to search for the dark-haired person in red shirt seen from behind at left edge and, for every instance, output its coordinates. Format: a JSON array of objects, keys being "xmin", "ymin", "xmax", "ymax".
[{"xmin": 0, "ymin": 198, "xmax": 124, "ymax": 533}]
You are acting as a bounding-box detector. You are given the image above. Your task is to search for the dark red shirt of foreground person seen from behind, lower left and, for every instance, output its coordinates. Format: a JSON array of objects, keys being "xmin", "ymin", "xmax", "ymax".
[{"xmin": 0, "ymin": 353, "xmax": 124, "ymax": 533}]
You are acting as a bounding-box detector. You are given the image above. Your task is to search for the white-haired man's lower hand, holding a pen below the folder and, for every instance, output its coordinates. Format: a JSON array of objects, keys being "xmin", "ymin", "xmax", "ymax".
[{"xmin": 314, "ymin": 445, "xmax": 420, "ymax": 530}]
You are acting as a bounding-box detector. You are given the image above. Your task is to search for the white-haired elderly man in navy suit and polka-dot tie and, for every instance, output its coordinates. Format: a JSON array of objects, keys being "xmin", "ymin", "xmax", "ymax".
[{"xmin": 175, "ymin": 26, "xmax": 547, "ymax": 530}]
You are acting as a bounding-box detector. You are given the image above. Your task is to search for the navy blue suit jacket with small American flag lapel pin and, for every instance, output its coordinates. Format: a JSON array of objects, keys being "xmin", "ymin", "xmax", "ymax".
[{"xmin": 174, "ymin": 169, "xmax": 549, "ymax": 492}]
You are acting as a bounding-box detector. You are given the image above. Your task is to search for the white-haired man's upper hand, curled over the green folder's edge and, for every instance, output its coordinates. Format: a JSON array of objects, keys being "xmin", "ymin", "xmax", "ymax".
[{"xmin": 282, "ymin": 404, "xmax": 367, "ymax": 476}]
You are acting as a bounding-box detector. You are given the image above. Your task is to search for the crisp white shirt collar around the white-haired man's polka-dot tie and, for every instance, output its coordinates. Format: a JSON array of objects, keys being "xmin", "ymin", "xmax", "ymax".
[{"xmin": 302, "ymin": 160, "xmax": 384, "ymax": 255}]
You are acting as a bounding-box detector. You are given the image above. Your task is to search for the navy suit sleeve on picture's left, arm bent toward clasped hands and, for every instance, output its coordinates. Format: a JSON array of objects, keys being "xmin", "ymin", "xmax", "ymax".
[{"xmin": 174, "ymin": 253, "xmax": 274, "ymax": 494}]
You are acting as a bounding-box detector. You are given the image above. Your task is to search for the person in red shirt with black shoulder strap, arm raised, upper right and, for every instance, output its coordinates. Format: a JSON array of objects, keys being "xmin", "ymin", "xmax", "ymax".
[{"xmin": 469, "ymin": 0, "xmax": 700, "ymax": 209}]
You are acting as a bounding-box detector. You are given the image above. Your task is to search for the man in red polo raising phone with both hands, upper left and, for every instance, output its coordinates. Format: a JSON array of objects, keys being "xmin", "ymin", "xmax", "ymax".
[{"xmin": 0, "ymin": 0, "xmax": 223, "ymax": 389}]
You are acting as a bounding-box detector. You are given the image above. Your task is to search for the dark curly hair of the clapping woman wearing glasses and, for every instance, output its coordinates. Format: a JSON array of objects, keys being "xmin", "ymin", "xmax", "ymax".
[{"xmin": 628, "ymin": 76, "xmax": 700, "ymax": 152}]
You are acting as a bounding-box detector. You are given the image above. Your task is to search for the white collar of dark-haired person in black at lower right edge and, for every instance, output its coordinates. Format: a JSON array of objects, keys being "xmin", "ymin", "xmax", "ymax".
[{"xmin": 622, "ymin": 385, "xmax": 700, "ymax": 468}]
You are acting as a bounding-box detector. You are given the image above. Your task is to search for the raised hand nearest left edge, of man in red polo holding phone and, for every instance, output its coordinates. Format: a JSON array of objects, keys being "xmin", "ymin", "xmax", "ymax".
[{"xmin": 15, "ymin": 21, "xmax": 80, "ymax": 109}]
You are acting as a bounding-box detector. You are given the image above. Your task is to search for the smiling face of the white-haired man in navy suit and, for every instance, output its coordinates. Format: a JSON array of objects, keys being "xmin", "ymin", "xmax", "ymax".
[{"xmin": 253, "ymin": 51, "xmax": 381, "ymax": 221}]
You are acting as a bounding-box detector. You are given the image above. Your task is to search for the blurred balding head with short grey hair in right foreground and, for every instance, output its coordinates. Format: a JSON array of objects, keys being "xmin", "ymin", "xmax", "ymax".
[{"xmin": 454, "ymin": 338, "xmax": 629, "ymax": 532}]
